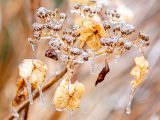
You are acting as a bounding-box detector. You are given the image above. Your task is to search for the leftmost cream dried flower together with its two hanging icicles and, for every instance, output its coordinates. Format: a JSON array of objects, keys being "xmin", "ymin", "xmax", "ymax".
[{"xmin": 19, "ymin": 59, "xmax": 47, "ymax": 104}]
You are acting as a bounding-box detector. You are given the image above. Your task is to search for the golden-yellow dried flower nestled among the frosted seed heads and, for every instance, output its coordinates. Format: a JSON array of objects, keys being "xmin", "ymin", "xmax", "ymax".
[{"xmin": 79, "ymin": 20, "xmax": 106, "ymax": 51}]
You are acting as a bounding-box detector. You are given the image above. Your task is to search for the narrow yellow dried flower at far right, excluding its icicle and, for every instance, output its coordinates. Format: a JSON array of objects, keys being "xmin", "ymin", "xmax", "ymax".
[{"xmin": 130, "ymin": 56, "xmax": 148, "ymax": 89}]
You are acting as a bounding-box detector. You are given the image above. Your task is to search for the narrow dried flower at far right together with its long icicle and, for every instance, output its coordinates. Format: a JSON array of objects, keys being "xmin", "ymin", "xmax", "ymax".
[{"xmin": 126, "ymin": 56, "xmax": 149, "ymax": 114}]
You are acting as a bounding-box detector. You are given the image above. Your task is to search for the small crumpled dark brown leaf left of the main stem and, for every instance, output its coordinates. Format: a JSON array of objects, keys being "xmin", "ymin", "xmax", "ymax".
[{"xmin": 45, "ymin": 49, "xmax": 58, "ymax": 60}]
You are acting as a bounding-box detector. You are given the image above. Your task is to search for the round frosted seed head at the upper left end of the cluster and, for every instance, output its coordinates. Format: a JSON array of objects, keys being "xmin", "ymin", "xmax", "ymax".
[{"xmin": 37, "ymin": 7, "xmax": 49, "ymax": 19}]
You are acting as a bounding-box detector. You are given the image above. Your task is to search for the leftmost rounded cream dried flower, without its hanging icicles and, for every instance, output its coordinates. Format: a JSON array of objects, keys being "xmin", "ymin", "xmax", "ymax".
[{"xmin": 19, "ymin": 59, "xmax": 47, "ymax": 88}]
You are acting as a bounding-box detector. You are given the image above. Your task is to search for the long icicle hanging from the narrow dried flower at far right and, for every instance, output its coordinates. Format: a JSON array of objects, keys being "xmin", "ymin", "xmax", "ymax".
[{"xmin": 126, "ymin": 89, "xmax": 135, "ymax": 114}]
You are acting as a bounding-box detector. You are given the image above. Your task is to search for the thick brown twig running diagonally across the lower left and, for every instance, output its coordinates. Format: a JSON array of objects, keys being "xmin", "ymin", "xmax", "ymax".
[{"xmin": 5, "ymin": 68, "xmax": 67, "ymax": 120}]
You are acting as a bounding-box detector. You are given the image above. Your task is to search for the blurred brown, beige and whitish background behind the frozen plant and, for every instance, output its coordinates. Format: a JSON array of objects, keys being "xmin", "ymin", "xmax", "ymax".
[{"xmin": 0, "ymin": 0, "xmax": 160, "ymax": 120}]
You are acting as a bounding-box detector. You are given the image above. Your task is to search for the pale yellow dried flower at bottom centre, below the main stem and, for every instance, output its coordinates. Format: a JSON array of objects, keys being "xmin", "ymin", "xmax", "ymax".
[{"xmin": 53, "ymin": 79, "xmax": 85, "ymax": 110}]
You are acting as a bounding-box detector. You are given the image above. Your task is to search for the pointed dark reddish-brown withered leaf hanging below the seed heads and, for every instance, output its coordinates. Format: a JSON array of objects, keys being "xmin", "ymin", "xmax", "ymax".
[{"xmin": 95, "ymin": 63, "xmax": 109, "ymax": 86}]
